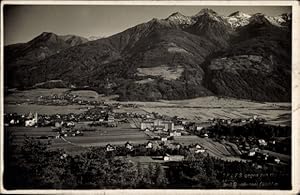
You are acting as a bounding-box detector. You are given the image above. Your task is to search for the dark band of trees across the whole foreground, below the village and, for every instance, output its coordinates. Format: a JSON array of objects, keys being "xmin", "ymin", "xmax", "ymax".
[{"xmin": 4, "ymin": 133, "xmax": 291, "ymax": 189}]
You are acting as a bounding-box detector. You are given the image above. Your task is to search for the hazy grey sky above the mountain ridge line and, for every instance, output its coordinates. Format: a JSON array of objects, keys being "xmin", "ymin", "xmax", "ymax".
[{"xmin": 4, "ymin": 5, "xmax": 291, "ymax": 45}]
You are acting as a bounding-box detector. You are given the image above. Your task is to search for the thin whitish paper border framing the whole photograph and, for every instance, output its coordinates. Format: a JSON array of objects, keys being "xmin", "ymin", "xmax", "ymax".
[{"xmin": 0, "ymin": 0, "xmax": 300, "ymax": 195}]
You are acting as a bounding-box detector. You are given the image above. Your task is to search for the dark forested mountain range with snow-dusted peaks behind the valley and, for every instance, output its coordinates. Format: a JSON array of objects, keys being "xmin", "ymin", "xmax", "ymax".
[{"xmin": 4, "ymin": 9, "xmax": 291, "ymax": 101}]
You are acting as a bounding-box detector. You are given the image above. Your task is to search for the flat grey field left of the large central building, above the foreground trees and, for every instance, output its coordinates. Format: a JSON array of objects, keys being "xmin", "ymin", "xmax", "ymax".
[{"xmin": 7, "ymin": 123, "xmax": 148, "ymax": 152}]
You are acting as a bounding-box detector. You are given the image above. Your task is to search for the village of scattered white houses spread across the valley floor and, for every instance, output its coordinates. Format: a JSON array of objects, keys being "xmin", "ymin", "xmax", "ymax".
[{"xmin": 4, "ymin": 100, "xmax": 290, "ymax": 167}]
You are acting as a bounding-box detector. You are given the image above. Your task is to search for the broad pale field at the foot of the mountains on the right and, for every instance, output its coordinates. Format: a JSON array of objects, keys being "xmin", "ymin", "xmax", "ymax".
[{"xmin": 138, "ymin": 97, "xmax": 291, "ymax": 125}]
